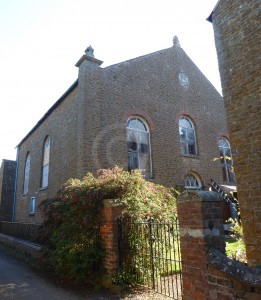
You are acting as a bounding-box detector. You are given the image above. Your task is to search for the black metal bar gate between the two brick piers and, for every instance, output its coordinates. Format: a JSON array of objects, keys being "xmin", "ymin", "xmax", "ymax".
[{"xmin": 118, "ymin": 218, "xmax": 182, "ymax": 299}]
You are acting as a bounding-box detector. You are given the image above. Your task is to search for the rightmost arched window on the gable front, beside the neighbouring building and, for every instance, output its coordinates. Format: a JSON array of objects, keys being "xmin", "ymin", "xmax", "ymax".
[{"xmin": 218, "ymin": 138, "xmax": 235, "ymax": 183}]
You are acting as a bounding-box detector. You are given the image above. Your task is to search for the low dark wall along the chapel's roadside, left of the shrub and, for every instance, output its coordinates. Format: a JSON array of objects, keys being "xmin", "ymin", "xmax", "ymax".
[{"xmin": 0, "ymin": 221, "xmax": 41, "ymax": 243}]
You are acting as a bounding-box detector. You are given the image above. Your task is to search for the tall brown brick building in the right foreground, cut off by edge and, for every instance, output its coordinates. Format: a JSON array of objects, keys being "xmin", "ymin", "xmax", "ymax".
[{"xmin": 209, "ymin": 0, "xmax": 261, "ymax": 266}]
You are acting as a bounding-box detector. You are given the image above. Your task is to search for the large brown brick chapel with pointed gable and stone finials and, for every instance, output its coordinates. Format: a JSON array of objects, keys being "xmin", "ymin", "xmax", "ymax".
[{"xmin": 15, "ymin": 38, "xmax": 231, "ymax": 222}]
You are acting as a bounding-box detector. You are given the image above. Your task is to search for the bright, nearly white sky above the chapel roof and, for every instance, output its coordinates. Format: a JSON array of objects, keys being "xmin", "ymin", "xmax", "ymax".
[{"xmin": 0, "ymin": 0, "xmax": 221, "ymax": 164}]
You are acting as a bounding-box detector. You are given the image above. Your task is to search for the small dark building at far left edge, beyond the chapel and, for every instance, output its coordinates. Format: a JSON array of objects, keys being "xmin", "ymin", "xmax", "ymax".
[{"xmin": 0, "ymin": 159, "xmax": 16, "ymax": 222}]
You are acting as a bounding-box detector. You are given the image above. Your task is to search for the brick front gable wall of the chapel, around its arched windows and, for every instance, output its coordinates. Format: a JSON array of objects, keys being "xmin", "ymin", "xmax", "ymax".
[{"xmin": 100, "ymin": 46, "xmax": 227, "ymax": 186}]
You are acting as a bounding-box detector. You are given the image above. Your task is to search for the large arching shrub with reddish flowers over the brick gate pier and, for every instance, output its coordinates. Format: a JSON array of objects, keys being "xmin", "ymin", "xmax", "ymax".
[{"xmin": 40, "ymin": 167, "xmax": 176, "ymax": 282}]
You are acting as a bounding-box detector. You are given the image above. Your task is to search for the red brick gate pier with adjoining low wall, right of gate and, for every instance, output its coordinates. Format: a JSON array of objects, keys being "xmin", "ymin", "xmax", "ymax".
[{"xmin": 177, "ymin": 191, "xmax": 261, "ymax": 300}]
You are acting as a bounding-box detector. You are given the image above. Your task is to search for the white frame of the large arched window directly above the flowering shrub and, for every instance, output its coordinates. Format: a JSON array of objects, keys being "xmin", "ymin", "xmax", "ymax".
[{"xmin": 126, "ymin": 116, "xmax": 152, "ymax": 178}]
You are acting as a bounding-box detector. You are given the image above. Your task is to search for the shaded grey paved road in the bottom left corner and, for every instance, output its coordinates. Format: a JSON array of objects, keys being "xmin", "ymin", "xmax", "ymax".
[{"xmin": 0, "ymin": 250, "xmax": 120, "ymax": 300}]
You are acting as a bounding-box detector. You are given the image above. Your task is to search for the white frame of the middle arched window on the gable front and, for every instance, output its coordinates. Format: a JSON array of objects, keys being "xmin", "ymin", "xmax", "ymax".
[{"xmin": 179, "ymin": 116, "xmax": 198, "ymax": 156}]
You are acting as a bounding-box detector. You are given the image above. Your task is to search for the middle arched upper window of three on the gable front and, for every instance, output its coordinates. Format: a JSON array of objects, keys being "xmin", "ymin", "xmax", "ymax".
[{"xmin": 179, "ymin": 117, "xmax": 197, "ymax": 155}]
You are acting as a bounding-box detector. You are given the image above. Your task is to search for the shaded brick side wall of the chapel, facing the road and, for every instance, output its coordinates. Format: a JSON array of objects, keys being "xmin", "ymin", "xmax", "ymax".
[{"xmin": 15, "ymin": 88, "xmax": 78, "ymax": 222}]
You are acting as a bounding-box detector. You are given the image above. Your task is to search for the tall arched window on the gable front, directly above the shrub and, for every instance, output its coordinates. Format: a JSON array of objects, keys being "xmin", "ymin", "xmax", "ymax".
[{"xmin": 126, "ymin": 117, "xmax": 151, "ymax": 178}]
